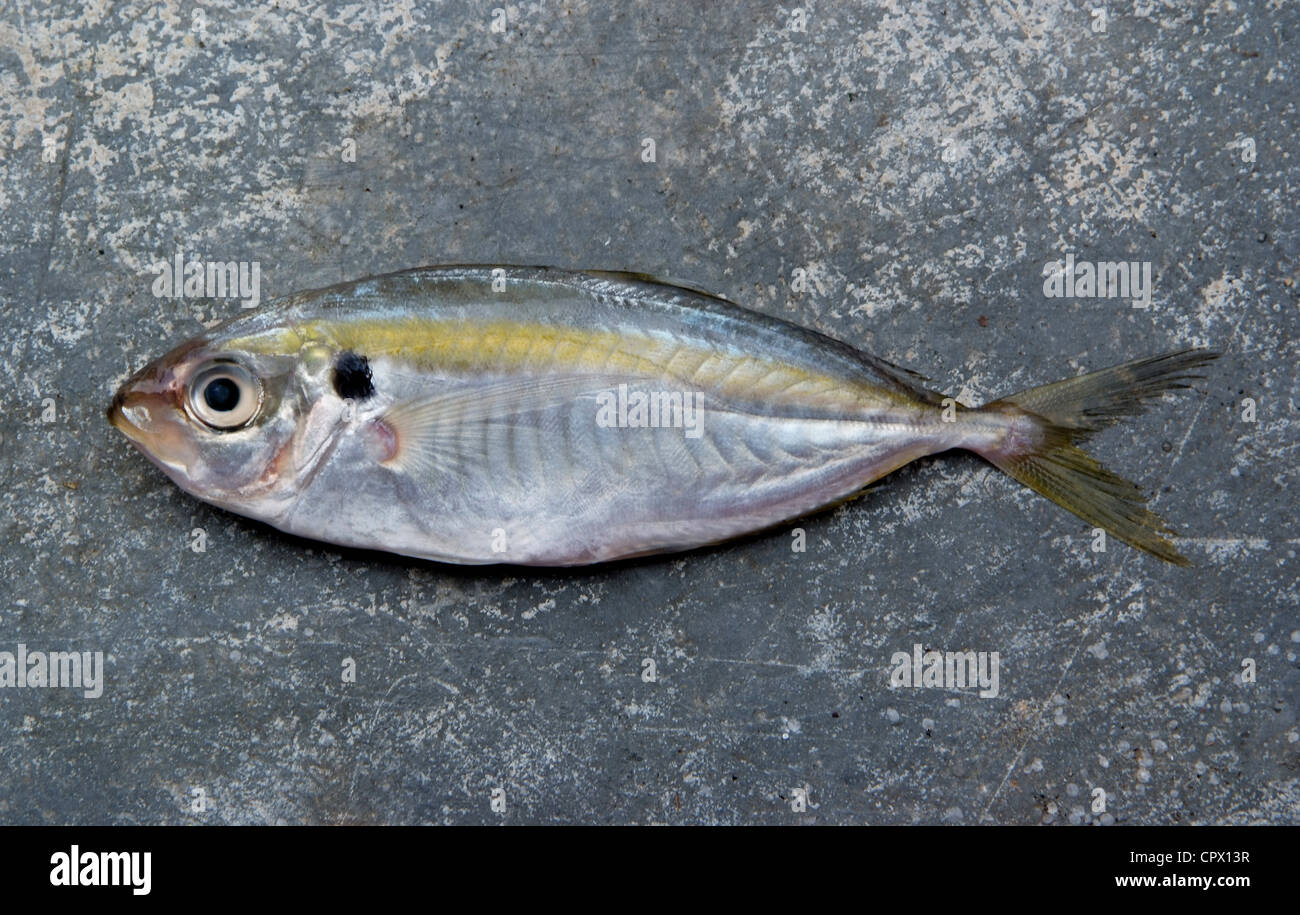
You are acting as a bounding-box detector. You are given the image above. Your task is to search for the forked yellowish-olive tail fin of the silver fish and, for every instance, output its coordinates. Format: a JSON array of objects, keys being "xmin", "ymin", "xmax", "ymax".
[{"xmin": 972, "ymin": 350, "xmax": 1222, "ymax": 565}]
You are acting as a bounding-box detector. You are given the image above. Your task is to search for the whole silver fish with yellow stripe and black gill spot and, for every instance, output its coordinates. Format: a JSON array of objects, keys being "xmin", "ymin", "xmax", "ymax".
[{"xmin": 108, "ymin": 265, "xmax": 1221, "ymax": 567}]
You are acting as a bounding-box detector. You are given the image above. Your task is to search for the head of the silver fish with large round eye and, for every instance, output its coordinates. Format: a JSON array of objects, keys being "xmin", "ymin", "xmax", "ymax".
[{"xmin": 108, "ymin": 333, "xmax": 311, "ymax": 519}]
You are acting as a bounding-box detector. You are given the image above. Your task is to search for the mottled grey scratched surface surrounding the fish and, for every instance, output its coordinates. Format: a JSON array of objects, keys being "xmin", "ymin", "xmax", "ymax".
[{"xmin": 0, "ymin": 0, "xmax": 1300, "ymax": 824}]
